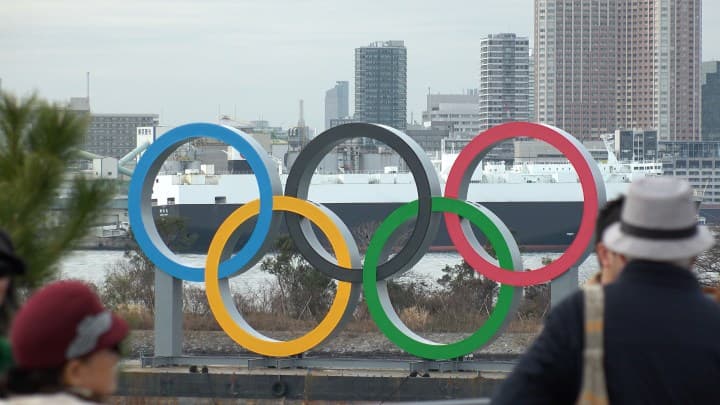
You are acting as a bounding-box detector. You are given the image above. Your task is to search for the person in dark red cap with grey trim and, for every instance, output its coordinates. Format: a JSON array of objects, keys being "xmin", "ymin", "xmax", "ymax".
[{"xmin": 7, "ymin": 281, "xmax": 128, "ymax": 405}]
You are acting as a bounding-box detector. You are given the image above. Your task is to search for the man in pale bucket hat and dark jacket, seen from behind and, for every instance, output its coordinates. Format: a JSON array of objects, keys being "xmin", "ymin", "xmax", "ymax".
[{"xmin": 493, "ymin": 177, "xmax": 720, "ymax": 404}]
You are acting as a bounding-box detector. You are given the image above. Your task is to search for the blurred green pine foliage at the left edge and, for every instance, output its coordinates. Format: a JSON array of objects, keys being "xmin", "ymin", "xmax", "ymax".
[{"xmin": 0, "ymin": 94, "xmax": 114, "ymax": 288}]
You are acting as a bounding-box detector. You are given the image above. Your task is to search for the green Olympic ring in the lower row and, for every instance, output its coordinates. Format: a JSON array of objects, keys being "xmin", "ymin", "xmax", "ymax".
[{"xmin": 363, "ymin": 197, "xmax": 517, "ymax": 360}]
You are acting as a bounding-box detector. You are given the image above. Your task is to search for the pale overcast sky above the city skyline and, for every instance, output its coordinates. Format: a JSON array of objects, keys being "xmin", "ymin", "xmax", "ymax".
[{"xmin": 0, "ymin": 0, "xmax": 720, "ymax": 130}]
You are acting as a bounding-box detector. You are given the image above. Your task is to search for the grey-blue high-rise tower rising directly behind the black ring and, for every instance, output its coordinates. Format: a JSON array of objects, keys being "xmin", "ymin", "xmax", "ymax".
[{"xmin": 355, "ymin": 41, "xmax": 407, "ymax": 129}]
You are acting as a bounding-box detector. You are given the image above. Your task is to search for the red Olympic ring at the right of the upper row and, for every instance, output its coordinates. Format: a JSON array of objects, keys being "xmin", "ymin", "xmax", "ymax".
[{"xmin": 445, "ymin": 122, "xmax": 602, "ymax": 287}]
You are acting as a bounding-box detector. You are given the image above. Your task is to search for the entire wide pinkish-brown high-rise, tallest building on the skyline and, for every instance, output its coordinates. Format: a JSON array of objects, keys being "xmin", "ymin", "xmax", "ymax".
[{"xmin": 534, "ymin": 0, "xmax": 701, "ymax": 140}]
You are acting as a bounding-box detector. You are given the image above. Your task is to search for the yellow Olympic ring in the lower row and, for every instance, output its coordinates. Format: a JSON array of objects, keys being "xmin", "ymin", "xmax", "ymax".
[{"xmin": 205, "ymin": 196, "xmax": 352, "ymax": 357}]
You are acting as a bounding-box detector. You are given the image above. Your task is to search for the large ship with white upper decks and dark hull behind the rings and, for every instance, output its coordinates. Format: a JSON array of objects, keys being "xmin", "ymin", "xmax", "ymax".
[{"xmin": 152, "ymin": 145, "xmax": 662, "ymax": 252}]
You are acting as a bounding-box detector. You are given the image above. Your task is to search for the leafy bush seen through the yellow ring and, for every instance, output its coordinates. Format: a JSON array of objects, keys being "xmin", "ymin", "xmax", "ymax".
[{"xmin": 260, "ymin": 236, "xmax": 335, "ymax": 320}]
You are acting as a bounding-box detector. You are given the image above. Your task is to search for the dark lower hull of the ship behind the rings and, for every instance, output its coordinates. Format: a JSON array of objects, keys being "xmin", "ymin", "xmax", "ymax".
[{"xmin": 153, "ymin": 201, "xmax": 582, "ymax": 253}]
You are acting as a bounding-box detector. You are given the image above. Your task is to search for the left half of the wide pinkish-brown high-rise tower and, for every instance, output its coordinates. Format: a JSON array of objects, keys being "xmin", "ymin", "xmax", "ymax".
[{"xmin": 534, "ymin": 0, "xmax": 617, "ymax": 139}]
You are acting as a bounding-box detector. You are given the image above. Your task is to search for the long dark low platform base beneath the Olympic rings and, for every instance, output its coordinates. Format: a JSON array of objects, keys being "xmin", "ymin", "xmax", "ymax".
[{"xmin": 117, "ymin": 368, "xmax": 503, "ymax": 403}]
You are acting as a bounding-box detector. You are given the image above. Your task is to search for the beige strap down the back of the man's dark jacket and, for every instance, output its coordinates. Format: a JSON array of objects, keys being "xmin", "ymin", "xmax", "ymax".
[{"xmin": 578, "ymin": 285, "xmax": 609, "ymax": 405}]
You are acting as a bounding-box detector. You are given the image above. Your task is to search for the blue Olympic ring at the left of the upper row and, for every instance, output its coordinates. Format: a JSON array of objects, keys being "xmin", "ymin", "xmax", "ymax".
[{"xmin": 128, "ymin": 123, "xmax": 281, "ymax": 282}]
